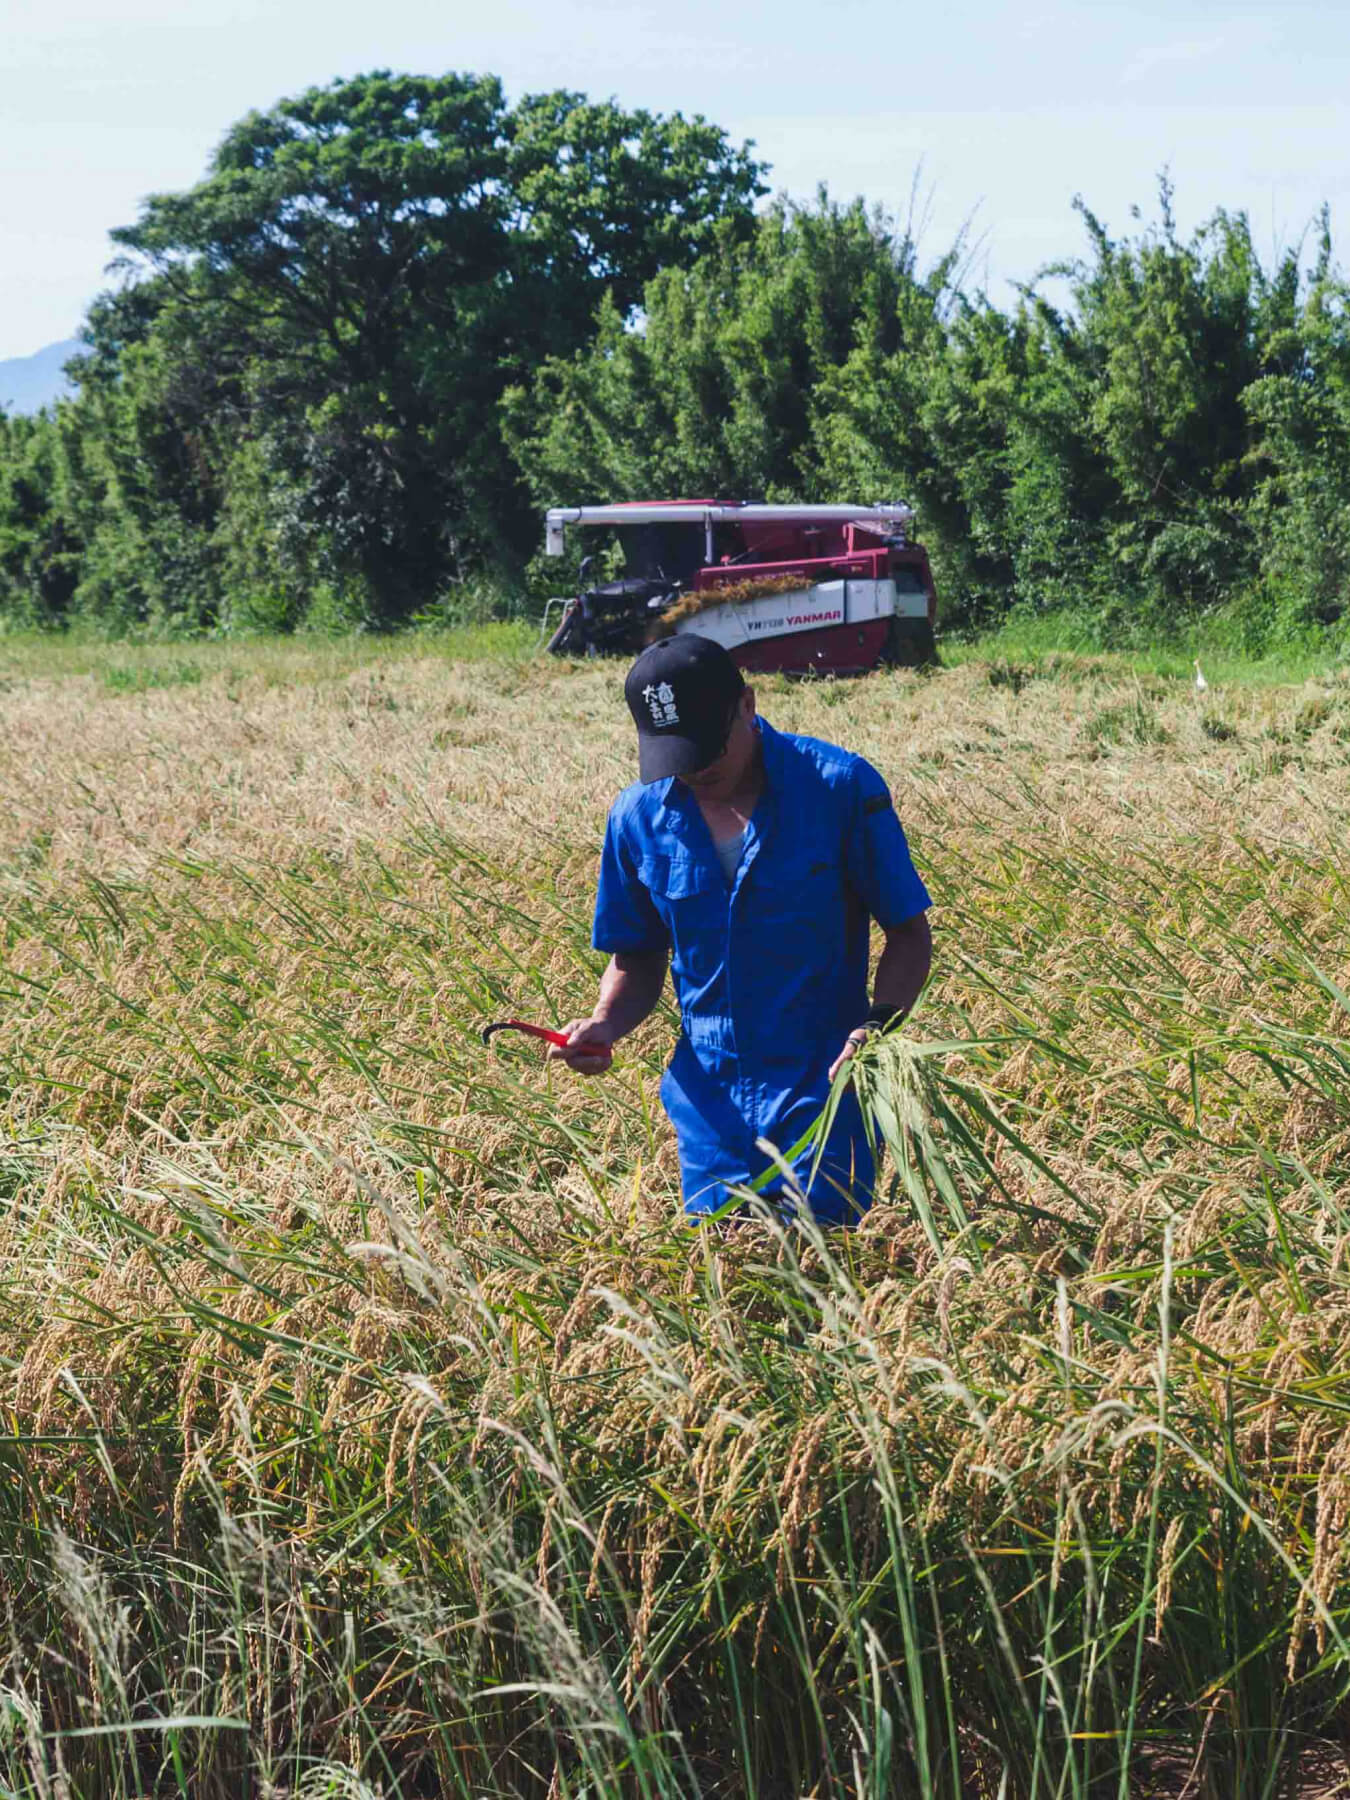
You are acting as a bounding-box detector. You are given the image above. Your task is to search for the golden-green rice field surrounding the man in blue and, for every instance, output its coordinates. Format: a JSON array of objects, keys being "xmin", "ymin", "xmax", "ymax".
[{"xmin": 0, "ymin": 632, "xmax": 1350, "ymax": 1800}]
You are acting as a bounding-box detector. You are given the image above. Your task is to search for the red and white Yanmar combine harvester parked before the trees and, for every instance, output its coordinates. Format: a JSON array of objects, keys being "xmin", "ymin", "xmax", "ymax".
[{"xmin": 545, "ymin": 500, "xmax": 938, "ymax": 675}]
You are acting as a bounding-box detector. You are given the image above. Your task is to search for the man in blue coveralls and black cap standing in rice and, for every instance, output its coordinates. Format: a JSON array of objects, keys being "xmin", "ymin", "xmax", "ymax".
[{"xmin": 549, "ymin": 634, "xmax": 932, "ymax": 1224}]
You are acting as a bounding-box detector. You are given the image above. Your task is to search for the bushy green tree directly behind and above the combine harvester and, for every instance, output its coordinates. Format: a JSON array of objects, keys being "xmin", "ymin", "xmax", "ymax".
[{"xmin": 504, "ymin": 193, "xmax": 943, "ymax": 504}]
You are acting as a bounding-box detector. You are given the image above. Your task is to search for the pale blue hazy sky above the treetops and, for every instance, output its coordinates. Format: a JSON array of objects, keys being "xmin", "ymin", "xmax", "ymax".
[{"xmin": 0, "ymin": 0, "xmax": 1350, "ymax": 358}]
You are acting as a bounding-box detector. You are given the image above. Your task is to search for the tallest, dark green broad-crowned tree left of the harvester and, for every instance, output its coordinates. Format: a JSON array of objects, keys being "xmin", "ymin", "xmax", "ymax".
[{"xmin": 90, "ymin": 74, "xmax": 761, "ymax": 621}]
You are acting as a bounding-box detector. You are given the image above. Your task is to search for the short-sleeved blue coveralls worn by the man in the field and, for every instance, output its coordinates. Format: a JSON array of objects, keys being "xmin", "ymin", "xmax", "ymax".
[{"xmin": 592, "ymin": 720, "xmax": 931, "ymax": 1224}]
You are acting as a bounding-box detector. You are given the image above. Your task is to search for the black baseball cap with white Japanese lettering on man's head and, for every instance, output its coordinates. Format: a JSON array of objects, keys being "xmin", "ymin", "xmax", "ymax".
[{"xmin": 623, "ymin": 632, "xmax": 745, "ymax": 781}]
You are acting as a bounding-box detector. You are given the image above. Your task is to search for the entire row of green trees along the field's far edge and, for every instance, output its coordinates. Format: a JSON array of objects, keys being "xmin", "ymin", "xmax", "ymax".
[{"xmin": 0, "ymin": 74, "xmax": 1350, "ymax": 648}]
